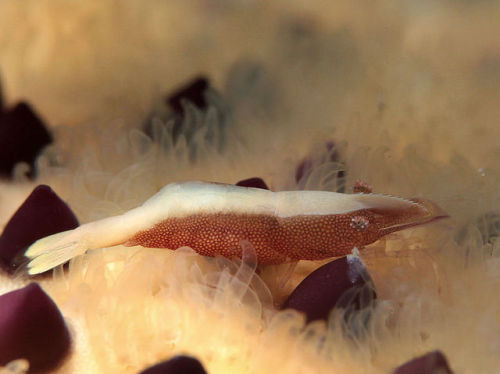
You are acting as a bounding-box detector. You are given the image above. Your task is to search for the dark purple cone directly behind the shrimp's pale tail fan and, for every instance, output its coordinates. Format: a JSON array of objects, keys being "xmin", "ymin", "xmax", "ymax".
[{"xmin": 0, "ymin": 184, "xmax": 79, "ymax": 271}]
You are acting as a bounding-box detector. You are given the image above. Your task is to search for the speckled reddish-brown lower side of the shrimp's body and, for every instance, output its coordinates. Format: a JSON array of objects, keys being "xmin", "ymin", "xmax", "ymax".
[{"xmin": 126, "ymin": 207, "xmax": 428, "ymax": 265}]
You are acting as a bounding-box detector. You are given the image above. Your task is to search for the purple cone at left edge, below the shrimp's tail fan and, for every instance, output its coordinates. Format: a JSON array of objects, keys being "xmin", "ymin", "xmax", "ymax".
[{"xmin": 0, "ymin": 283, "xmax": 71, "ymax": 373}]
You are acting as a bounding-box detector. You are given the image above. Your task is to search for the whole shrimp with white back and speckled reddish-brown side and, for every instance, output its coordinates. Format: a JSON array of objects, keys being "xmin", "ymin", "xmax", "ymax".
[{"xmin": 26, "ymin": 182, "xmax": 444, "ymax": 274}]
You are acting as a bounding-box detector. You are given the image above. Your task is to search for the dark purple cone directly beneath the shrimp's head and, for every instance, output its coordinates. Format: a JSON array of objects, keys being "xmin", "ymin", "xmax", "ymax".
[{"xmin": 283, "ymin": 255, "xmax": 376, "ymax": 322}]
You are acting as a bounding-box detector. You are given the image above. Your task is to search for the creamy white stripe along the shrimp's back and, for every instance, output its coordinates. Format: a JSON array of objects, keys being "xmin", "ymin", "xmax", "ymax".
[{"xmin": 142, "ymin": 182, "xmax": 419, "ymax": 219}]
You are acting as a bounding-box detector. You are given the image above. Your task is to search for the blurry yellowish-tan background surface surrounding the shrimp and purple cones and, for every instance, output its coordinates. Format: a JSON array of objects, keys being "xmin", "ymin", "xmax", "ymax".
[{"xmin": 0, "ymin": 0, "xmax": 500, "ymax": 374}]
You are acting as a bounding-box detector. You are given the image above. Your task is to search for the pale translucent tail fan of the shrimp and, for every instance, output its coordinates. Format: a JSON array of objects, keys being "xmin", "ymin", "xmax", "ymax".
[{"xmin": 24, "ymin": 229, "xmax": 88, "ymax": 274}]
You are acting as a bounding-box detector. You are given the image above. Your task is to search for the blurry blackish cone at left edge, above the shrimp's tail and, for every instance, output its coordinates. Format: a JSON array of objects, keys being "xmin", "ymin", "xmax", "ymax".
[{"xmin": 0, "ymin": 102, "xmax": 52, "ymax": 178}]
